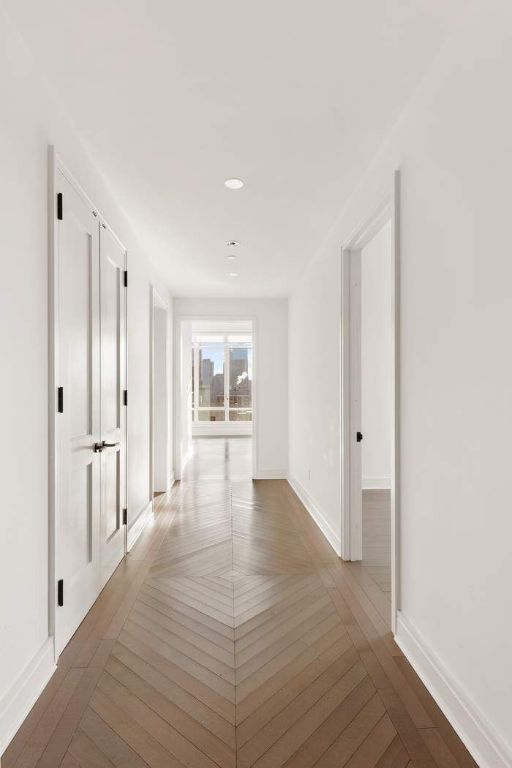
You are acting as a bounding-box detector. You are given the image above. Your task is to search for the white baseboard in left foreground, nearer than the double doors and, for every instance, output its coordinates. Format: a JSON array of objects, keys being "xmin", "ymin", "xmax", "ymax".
[{"xmin": 0, "ymin": 637, "xmax": 57, "ymax": 756}]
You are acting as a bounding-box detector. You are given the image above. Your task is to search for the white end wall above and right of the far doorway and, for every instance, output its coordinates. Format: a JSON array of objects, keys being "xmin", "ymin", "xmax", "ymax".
[{"xmin": 174, "ymin": 298, "xmax": 288, "ymax": 478}]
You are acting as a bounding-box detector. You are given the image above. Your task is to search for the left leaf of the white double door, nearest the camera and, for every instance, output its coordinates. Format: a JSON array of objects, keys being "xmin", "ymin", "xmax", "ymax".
[{"xmin": 55, "ymin": 172, "xmax": 101, "ymax": 652}]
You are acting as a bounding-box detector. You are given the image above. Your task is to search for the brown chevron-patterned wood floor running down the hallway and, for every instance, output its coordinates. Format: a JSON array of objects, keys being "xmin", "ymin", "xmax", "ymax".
[{"xmin": 2, "ymin": 481, "xmax": 475, "ymax": 768}]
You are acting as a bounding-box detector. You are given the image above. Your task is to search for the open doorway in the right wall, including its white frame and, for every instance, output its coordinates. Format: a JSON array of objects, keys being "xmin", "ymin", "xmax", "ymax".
[{"xmin": 341, "ymin": 172, "xmax": 399, "ymax": 631}]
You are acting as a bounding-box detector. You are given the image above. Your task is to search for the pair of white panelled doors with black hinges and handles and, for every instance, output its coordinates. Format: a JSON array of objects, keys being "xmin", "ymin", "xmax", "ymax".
[{"xmin": 54, "ymin": 169, "xmax": 126, "ymax": 653}]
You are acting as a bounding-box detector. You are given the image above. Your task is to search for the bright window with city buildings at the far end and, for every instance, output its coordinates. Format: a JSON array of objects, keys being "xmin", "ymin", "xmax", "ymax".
[{"xmin": 192, "ymin": 334, "xmax": 252, "ymax": 422}]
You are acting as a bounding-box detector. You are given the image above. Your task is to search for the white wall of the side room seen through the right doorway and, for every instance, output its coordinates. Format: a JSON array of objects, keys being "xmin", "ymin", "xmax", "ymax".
[{"xmin": 361, "ymin": 222, "xmax": 393, "ymax": 488}]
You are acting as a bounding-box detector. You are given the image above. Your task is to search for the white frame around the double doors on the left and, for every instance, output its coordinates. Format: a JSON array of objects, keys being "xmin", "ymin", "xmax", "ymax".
[{"xmin": 47, "ymin": 145, "xmax": 128, "ymax": 662}]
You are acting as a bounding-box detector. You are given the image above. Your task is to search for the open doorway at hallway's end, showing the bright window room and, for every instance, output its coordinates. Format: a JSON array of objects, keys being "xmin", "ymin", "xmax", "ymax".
[{"xmin": 180, "ymin": 319, "xmax": 254, "ymax": 481}]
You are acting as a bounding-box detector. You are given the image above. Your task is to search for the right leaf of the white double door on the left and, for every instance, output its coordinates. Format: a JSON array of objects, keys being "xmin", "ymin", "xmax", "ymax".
[{"xmin": 100, "ymin": 225, "xmax": 126, "ymax": 584}]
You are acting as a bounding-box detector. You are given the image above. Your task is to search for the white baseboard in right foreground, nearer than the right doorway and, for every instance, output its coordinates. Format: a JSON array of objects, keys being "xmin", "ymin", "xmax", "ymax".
[{"xmin": 395, "ymin": 611, "xmax": 512, "ymax": 768}]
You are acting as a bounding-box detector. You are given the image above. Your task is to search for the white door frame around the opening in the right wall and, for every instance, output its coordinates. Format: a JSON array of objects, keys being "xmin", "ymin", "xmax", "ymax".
[{"xmin": 340, "ymin": 170, "xmax": 401, "ymax": 633}]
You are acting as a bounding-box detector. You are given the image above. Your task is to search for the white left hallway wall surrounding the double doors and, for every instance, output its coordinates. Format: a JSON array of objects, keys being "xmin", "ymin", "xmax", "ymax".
[{"xmin": 0, "ymin": 6, "xmax": 168, "ymax": 754}]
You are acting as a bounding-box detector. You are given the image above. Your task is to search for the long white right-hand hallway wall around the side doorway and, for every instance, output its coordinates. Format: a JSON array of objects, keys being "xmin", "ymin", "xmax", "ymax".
[{"xmin": 289, "ymin": 0, "xmax": 512, "ymax": 768}]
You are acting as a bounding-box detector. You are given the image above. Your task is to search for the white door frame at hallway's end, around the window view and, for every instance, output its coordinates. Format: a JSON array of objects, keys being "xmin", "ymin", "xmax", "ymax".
[{"xmin": 173, "ymin": 314, "xmax": 259, "ymax": 480}]
